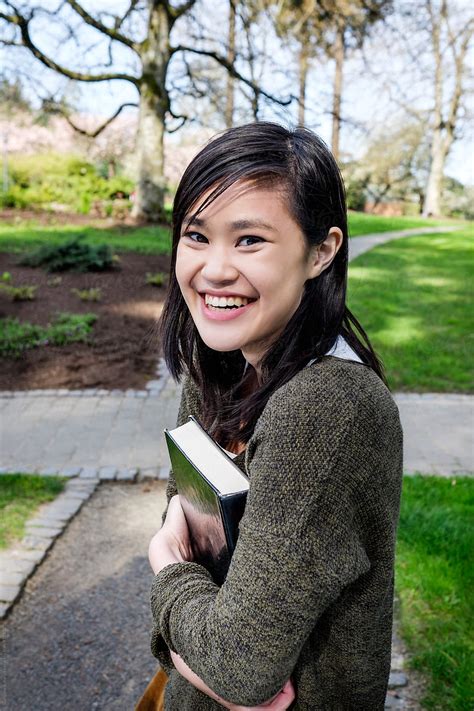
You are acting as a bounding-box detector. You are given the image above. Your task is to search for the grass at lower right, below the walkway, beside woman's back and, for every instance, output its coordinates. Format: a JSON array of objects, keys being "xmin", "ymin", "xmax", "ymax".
[{"xmin": 396, "ymin": 475, "xmax": 474, "ymax": 711}]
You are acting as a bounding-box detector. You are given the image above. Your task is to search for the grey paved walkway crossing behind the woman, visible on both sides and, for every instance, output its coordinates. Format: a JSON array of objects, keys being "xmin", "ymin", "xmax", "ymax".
[{"xmin": 0, "ymin": 377, "xmax": 474, "ymax": 479}]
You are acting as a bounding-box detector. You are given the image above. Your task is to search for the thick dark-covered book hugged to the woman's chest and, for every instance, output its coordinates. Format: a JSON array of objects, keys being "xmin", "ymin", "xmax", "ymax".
[{"xmin": 164, "ymin": 415, "xmax": 249, "ymax": 585}]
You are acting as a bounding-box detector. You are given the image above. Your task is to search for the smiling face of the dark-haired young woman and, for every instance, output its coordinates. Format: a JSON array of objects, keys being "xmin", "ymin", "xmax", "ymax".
[{"xmin": 176, "ymin": 182, "xmax": 321, "ymax": 367}]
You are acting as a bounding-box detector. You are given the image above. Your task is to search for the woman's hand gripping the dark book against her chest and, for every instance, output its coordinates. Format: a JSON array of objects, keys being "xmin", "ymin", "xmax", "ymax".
[{"xmin": 148, "ymin": 495, "xmax": 193, "ymax": 575}]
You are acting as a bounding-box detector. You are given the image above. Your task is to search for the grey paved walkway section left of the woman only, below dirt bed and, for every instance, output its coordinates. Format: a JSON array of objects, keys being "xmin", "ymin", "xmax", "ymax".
[{"xmin": 0, "ymin": 372, "xmax": 179, "ymax": 476}]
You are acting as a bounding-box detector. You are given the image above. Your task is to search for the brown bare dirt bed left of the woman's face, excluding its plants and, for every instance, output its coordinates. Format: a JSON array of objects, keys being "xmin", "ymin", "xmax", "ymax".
[{"xmin": 0, "ymin": 254, "xmax": 169, "ymax": 390}]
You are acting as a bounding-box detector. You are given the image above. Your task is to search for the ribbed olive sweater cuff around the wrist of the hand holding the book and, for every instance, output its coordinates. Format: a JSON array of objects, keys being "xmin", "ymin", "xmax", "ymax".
[{"xmin": 151, "ymin": 562, "xmax": 219, "ymax": 654}]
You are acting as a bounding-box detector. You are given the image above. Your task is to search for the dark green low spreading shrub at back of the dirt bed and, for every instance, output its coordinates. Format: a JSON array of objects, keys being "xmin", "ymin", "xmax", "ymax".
[{"xmin": 20, "ymin": 236, "xmax": 115, "ymax": 272}]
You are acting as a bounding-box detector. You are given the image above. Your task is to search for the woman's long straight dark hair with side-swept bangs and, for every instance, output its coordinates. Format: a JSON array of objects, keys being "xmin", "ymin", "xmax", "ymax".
[{"xmin": 160, "ymin": 122, "xmax": 384, "ymax": 447}]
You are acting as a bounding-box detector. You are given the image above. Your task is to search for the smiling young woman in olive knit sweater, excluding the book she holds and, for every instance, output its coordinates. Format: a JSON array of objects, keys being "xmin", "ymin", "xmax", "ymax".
[{"xmin": 143, "ymin": 123, "xmax": 402, "ymax": 711}]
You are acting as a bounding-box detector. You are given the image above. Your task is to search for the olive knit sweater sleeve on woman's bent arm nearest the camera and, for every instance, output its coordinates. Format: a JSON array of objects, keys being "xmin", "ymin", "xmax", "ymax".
[{"xmin": 152, "ymin": 372, "xmax": 370, "ymax": 706}]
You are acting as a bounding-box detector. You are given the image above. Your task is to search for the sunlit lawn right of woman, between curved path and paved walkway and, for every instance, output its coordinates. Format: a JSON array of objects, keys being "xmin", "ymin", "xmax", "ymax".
[{"xmin": 349, "ymin": 229, "xmax": 474, "ymax": 392}]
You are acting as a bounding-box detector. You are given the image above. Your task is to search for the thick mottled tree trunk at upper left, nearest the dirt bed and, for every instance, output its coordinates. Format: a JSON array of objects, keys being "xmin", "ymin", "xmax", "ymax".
[{"xmin": 132, "ymin": 0, "xmax": 171, "ymax": 222}]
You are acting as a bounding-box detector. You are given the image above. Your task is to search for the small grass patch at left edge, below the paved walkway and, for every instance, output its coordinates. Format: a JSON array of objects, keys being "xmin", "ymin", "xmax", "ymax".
[{"xmin": 0, "ymin": 474, "xmax": 66, "ymax": 548}]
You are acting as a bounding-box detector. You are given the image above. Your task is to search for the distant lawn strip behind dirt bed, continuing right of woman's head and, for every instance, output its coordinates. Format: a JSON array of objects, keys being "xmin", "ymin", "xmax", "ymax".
[{"xmin": 0, "ymin": 212, "xmax": 460, "ymax": 254}]
